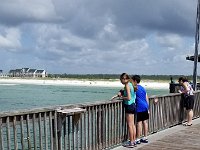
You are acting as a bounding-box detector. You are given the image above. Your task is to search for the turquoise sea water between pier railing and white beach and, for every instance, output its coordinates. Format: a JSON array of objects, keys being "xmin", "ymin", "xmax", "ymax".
[{"xmin": 0, "ymin": 84, "xmax": 169, "ymax": 112}]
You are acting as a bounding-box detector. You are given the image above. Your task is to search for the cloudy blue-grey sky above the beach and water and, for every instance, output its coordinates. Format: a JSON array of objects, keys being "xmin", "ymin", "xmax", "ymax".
[{"xmin": 0, "ymin": 0, "xmax": 199, "ymax": 75}]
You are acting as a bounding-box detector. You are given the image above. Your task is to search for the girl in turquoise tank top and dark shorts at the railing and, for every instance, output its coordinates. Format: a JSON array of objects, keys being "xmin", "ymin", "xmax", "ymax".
[{"xmin": 119, "ymin": 73, "xmax": 137, "ymax": 148}]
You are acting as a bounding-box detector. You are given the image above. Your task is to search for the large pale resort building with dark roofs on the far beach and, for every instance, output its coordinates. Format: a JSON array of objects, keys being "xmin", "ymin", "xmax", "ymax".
[{"xmin": 8, "ymin": 68, "xmax": 47, "ymax": 78}]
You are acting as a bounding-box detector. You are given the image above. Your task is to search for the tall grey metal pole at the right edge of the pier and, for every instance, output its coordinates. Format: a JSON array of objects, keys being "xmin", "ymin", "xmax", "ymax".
[{"xmin": 193, "ymin": 0, "xmax": 200, "ymax": 90}]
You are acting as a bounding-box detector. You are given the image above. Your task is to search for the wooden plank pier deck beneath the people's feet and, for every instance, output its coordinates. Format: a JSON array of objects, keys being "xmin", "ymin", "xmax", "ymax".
[{"xmin": 113, "ymin": 118, "xmax": 200, "ymax": 150}]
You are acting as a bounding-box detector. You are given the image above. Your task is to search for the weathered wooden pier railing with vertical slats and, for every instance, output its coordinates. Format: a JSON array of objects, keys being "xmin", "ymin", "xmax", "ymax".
[{"xmin": 0, "ymin": 91, "xmax": 200, "ymax": 150}]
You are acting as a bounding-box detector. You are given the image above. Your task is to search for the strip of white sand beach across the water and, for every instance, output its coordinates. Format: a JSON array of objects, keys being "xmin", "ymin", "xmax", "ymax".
[{"xmin": 0, "ymin": 78, "xmax": 169, "ymax": 89}]
